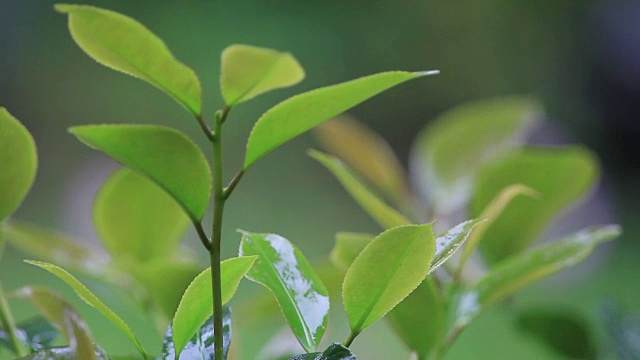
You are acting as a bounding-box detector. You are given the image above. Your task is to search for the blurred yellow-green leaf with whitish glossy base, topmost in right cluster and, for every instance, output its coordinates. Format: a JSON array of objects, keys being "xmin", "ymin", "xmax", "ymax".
[{"xmin": 410, "ymin": 97, "xmax": 537, "ymax": 214}]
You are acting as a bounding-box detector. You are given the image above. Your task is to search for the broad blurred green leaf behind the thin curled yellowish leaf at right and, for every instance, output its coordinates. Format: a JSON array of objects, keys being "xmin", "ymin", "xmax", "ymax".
[{"xmin": 471, "ymin": 147, "xmax": 599, "ymax": 265}]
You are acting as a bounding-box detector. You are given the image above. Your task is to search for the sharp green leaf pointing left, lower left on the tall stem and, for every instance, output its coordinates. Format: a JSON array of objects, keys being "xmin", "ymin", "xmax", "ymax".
[{"xmin": 69, "ymin": 125, "xmax": 211, "ymax": 221}]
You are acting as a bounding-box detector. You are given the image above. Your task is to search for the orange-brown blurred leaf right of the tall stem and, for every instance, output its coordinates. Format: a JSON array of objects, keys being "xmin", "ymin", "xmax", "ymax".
[{"xmin": 315, "ymin": 116, "xmax": 408, "ymax": 204}]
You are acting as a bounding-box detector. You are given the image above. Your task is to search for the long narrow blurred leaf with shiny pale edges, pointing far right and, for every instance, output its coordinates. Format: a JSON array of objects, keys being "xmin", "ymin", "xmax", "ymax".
[{"xmin": 457, "ymin": 225, "xmax": 620, "ymax": 326}]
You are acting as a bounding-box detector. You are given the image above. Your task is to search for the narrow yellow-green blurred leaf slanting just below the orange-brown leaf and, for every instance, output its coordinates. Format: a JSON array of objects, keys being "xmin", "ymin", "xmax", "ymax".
[{"xmin": 309, "ymin": 150, "xmax": 410, "ymax": 228}]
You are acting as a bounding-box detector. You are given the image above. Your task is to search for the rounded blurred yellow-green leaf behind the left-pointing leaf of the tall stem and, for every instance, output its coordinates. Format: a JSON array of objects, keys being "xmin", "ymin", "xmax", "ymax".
[{"xmin": 93, "ymin": 168, "xmax": 189, "ymax": 261}]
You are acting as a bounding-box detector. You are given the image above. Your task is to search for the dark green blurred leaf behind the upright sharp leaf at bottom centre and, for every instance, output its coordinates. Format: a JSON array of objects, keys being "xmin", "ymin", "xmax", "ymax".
[{"xmin": 387, "ymin": 277, "xmax": 447, "ymax": 359}]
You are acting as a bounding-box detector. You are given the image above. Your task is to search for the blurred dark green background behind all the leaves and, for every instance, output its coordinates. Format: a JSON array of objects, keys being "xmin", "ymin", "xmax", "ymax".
[{"xmin": 0, "ymin": 0, "xmax": 640, "ymax": 359}]
